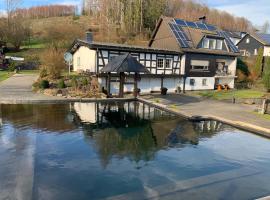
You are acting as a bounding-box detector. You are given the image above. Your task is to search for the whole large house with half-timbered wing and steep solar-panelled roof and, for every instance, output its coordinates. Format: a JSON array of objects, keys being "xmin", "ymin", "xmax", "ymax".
[{"xmin": 68, "ymin": 17, "xmax": 239, "ymax": 93}]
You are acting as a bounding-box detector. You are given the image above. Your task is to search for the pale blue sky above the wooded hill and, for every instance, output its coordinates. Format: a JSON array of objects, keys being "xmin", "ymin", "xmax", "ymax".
[{"xmin": 0, "ymin": 0, "xmax": 270, "ymax": 26}]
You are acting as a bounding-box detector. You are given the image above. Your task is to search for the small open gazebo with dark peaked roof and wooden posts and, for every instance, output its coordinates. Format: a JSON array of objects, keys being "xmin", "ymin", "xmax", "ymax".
[{"xmin": 100, "ymin": 54, "xmax": 150, "ymax": 98}]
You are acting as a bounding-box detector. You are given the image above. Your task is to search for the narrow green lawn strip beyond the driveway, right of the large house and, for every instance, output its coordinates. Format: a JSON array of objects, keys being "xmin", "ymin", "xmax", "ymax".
[{"xmin": 194, "ymin": 89, "xmax": 265, "ymax": 100}]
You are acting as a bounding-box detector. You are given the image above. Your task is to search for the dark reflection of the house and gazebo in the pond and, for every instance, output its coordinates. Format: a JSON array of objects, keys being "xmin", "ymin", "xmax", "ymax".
[{"xmin": 74, "ymin": 102, "xmax": 226, "ymax": 167}]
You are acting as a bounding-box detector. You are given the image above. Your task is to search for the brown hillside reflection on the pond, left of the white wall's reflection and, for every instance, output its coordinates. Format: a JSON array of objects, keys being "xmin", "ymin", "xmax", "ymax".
[{"xmin": 0, "ymin": 104, "xmax": 75, "ymax": 133}]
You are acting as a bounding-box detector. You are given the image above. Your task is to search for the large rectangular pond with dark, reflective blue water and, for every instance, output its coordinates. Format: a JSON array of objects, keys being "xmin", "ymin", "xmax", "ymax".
[{"xmin": 0, "ymin": 102, "xmax": 270, "ymax": 200}]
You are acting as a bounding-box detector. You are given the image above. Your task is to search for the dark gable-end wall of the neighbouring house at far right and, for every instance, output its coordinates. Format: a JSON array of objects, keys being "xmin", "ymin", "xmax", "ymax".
[{"xmin": 237, "ymin": 34, "xmax": 264, "ymax": 56}]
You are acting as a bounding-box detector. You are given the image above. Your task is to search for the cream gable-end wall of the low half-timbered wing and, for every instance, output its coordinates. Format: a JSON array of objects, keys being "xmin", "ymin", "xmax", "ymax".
[{"xmin": 73, "ymin": 46, "xmax": 97, "ymax": 72}]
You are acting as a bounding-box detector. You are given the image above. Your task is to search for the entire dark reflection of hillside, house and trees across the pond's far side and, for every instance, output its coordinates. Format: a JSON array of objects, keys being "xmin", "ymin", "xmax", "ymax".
[{"xmin": 0, "ymin": 102, "xmax": 228, "ymax": 167}]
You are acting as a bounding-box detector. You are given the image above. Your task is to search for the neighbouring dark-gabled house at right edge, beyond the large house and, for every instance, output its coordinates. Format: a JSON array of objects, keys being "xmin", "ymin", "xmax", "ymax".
[{"xmin": 237, "ymin": 33, "xmax": 270, "ymax": 57}]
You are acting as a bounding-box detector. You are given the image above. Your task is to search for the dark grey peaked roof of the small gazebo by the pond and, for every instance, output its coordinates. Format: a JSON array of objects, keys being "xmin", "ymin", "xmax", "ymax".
[{"xmin": 101, "ymin": 54, "xmax": 150, "ymax": 73}]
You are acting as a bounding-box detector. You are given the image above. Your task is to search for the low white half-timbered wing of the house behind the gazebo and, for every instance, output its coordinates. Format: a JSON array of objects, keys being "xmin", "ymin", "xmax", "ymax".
[{"xmin": 70, "ymin": 39, "xmax": 184, "ymax": 94}]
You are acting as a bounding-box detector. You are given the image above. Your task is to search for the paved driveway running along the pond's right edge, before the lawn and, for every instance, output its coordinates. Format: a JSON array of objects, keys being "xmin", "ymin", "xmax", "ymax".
[{"xmin": 140, "ymin": 95, "xmax": 270, "ymax": 135}]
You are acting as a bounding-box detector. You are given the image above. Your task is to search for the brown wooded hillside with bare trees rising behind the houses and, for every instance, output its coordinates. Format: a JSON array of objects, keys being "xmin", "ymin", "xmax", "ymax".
[{"xmin": 0, "ymin": 0, "xmax": 262, "ymax": 49}]
